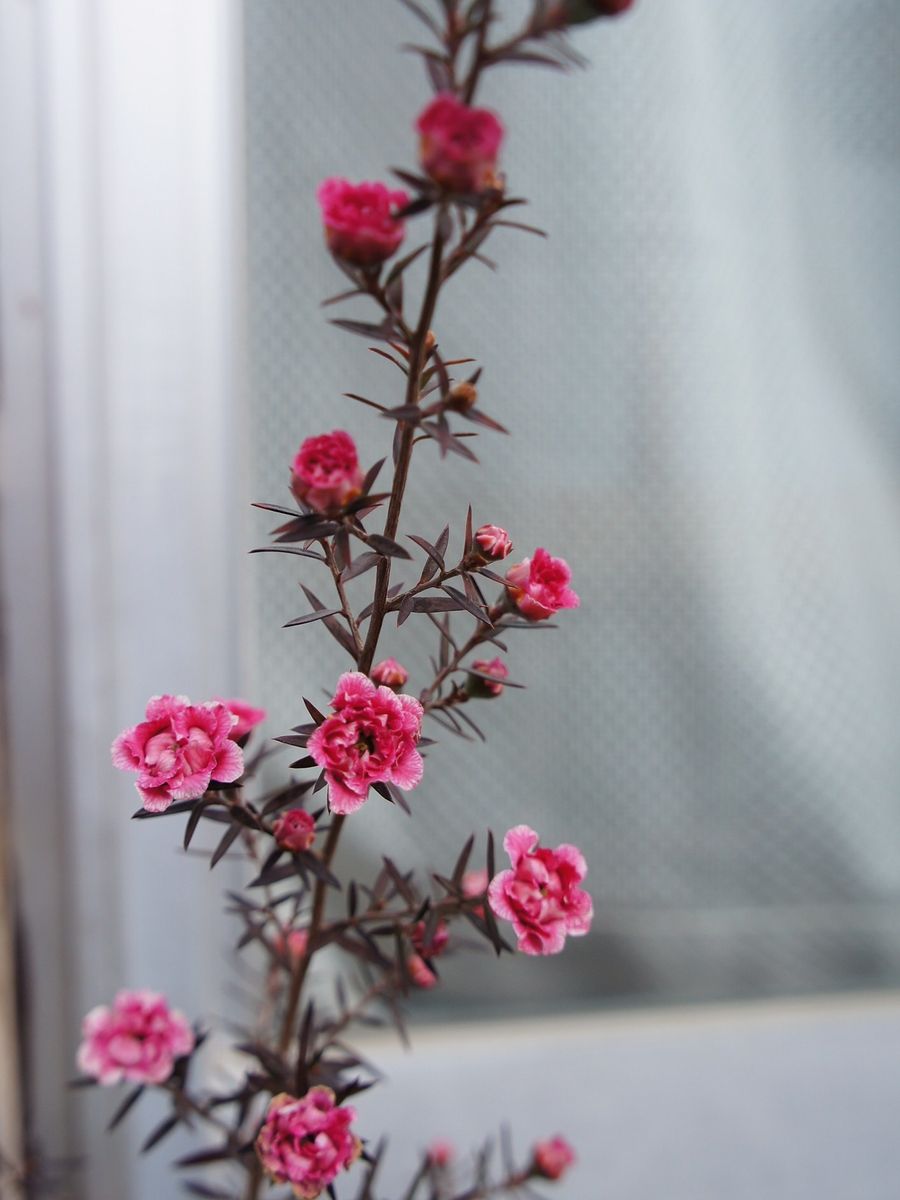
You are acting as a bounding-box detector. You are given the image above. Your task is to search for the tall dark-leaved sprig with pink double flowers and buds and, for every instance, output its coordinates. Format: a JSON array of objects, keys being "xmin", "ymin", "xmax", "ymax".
[{"xmin": 72, "ymin": 0, "xmax": 629, "ymax": 1200}]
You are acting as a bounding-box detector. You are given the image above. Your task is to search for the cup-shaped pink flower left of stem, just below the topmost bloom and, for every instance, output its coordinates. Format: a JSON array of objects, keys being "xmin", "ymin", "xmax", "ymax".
[{"xmin": 316, "ymin": 179, "xmax": 409, "ymax": 266}]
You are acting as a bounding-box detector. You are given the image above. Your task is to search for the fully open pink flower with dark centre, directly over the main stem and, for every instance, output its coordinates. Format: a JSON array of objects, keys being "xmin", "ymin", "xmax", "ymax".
[{"xmin": 308, "ymin": 671, "xmax": 422, "ymax": 814}]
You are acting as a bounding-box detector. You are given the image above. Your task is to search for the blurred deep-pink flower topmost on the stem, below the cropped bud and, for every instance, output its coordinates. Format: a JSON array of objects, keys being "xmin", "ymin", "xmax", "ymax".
[{"xmin": 415, "ymin": 91, "xmax": 503, "ymax": 192}]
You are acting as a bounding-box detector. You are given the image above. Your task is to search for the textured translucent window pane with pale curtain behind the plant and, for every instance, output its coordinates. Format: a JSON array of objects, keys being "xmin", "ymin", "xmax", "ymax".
[{"xmin": 245, "ymin": 0, "xmax": 900, "ymax": 1003}]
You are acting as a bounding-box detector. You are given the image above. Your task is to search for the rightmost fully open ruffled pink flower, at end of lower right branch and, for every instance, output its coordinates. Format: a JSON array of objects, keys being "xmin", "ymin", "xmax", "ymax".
[{"xmin": 487, "ymin": 826, "xmax": 594, "ymax": 954}]
